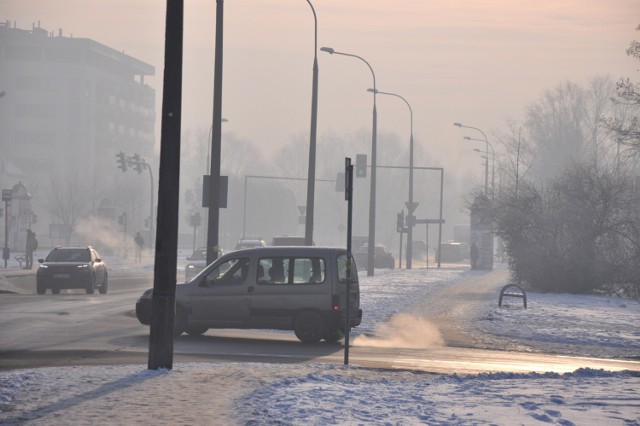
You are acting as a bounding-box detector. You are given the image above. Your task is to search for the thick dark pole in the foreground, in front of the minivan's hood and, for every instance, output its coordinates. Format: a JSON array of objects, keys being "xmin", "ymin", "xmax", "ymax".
[{"xmin": 148, "ymin": 0, "xmax": 184, "ymax": 370}]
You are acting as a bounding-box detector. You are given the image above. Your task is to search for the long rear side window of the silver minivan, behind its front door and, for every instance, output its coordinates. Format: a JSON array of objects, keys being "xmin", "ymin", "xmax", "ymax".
[{"xmin": 257, "ymin": 257, "xmax": 326, "ymax": 284}]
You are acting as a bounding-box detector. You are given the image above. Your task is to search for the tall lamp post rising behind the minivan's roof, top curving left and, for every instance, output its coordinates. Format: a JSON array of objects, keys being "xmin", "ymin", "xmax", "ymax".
[{"xmin": 304, "ymin": 0, "xmax": 318, "ymax": 246}]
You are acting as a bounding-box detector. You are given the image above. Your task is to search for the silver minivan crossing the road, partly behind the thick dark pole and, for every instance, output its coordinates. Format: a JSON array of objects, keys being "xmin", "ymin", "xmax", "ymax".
[{"xmin": 136, "ymin": 247, "xmax": 362, "ymax": 343}]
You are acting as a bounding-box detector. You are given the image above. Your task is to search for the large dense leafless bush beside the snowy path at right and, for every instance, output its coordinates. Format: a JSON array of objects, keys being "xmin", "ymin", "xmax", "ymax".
[{"xmin": 493, "ymin": 162, "xmax": 640, "ymax": 294}]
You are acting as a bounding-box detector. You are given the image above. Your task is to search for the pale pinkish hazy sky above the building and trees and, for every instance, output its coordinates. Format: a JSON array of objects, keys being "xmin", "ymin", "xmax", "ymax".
[{"xmin": 5, "ymin": 0, "xmax": 640, "ymax": 173}]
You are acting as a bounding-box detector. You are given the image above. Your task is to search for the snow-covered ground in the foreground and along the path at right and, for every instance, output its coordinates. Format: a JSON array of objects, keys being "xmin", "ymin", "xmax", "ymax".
[{"xmin": 0, "ymin": 267, "xmax": 640, "ymax": 425}]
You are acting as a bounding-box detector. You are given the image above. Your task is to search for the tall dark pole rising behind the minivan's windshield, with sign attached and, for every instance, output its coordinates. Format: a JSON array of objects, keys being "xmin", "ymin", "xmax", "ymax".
[{"xmin": 207, "ymin": 0, "xmax": 224, "ymax": 265}]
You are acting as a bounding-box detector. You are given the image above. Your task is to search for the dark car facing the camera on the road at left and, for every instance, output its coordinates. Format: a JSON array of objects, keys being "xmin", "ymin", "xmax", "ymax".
[{"xmin": 36, "ymin": 246, "xmax": 109, "ymax": 294}]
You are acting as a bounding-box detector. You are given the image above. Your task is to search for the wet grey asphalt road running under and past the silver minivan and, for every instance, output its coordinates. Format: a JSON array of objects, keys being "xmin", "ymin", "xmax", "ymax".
[{"xmin": 0, "ymin": 271, "xmax": 640, "ymax": 374}]
